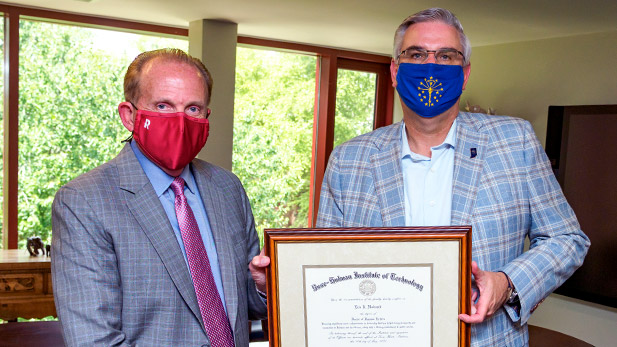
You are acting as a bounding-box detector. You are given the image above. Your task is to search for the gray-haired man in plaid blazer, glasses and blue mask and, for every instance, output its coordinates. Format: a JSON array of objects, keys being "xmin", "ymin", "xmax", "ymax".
[{"xmin": 317, "ymin": 9, "xmax": 589, "ymax": 346}]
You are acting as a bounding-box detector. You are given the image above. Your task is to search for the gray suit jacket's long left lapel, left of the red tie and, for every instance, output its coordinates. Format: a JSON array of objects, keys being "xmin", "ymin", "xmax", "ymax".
[{"xmin": 117, "ymin": 144, "xmax": 205, "ymax": 332}]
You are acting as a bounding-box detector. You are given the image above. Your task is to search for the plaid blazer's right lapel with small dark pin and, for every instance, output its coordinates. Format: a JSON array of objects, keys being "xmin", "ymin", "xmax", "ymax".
[{"xmin": 451, "ymin": 113, "xmax": 488, "ymax": 225}]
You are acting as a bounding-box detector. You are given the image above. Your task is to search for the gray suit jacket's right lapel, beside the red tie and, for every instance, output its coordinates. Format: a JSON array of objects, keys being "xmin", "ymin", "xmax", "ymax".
[{"xmin": 192, "ymin": 161, "xmax": 239, "ymax": 329}]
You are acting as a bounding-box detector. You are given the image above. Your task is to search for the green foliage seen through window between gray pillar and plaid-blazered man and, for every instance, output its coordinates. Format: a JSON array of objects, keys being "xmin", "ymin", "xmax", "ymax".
[{"xmin": 233, "ymin": 48, "xmax": 316, "ymax": 242}]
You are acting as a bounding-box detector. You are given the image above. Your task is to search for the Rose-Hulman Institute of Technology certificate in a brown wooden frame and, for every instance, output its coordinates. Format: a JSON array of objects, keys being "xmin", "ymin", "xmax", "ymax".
[{"xmin": 264, "ymin": 226, "xmax": 471, "ymax": 347}]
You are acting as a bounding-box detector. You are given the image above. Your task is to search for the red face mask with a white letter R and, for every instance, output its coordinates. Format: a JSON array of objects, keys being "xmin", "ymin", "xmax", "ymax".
[{"xmin": 133, "ymin": 110, "xmax": 210, "ymax": 171}]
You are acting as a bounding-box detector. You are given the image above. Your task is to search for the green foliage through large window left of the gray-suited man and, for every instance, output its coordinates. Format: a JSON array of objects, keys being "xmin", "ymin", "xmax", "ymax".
[{"xmin": 18, "ymin": 20, "xmax": 185, "ymax": 248}]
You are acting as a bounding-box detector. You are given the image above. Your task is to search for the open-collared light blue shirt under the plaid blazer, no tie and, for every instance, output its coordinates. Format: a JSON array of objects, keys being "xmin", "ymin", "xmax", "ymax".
[{"xmin": 401, "ymin": 120, "xmax": 456, "ymax": 226}]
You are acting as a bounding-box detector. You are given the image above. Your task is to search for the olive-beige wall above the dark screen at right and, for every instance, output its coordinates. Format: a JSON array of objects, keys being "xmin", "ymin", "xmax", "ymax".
[{"xmin": 461, "ymin": 31, "xmax": 617, "ymax": 143}]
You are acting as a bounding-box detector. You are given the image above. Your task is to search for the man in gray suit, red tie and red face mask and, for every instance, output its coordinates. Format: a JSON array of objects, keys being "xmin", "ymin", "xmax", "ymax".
[{"xmin": 52, "ymin": 49, "xmax": 267, "ymax": 347}]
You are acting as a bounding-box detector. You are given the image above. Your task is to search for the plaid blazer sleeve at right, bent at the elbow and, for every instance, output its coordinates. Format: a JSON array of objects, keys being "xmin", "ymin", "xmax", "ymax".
[{"xmin": 503, "ymin": 122, "xmax": 590, "ymax": 324}]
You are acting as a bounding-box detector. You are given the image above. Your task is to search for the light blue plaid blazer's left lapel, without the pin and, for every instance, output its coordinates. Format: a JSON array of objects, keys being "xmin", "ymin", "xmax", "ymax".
[{"xmin": 370, "ymin": 123, "xmax": 405, "ymax": 226}]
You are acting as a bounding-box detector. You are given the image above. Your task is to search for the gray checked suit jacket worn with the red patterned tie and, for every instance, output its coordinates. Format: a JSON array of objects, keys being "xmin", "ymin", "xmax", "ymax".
[{"xmin": 52, "ymin": 144, "xmax": 266, "ymax": 346}]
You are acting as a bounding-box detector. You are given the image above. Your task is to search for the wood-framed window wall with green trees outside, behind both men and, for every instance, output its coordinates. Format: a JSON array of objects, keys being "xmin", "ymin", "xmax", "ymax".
[{"xmin": 0, "ymin": 5, "xmax": 393, "ymax": 248}]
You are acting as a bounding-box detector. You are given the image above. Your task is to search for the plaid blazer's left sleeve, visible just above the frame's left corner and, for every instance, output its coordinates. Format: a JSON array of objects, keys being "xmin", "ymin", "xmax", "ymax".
[{"xmin": 316, "ymin": 148, "xmax": 344, "ymax": 228}]
